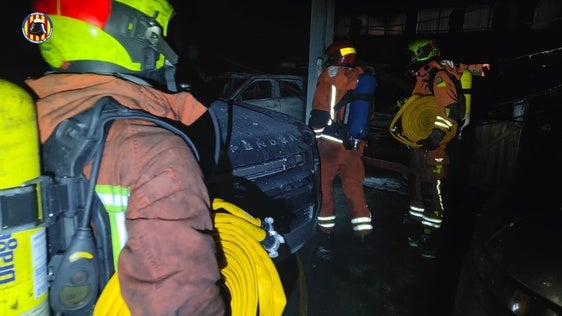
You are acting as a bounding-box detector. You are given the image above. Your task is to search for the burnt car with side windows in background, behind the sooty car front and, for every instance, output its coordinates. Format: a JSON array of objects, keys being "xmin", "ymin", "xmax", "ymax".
[{"xmin": 202, "ymin": 72, "xmax": 306, "ymax": 121}]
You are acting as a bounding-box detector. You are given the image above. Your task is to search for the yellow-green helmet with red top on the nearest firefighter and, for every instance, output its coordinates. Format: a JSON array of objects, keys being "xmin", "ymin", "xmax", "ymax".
[{"xmin": 33, "ymin": 0, "xmax": 178, "ymax": 89}]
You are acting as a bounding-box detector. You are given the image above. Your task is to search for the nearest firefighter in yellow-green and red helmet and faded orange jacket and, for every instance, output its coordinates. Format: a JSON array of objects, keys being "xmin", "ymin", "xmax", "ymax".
[{"xmin": 26, "ymin": 0, "xmax": 226, "ymax": 315}]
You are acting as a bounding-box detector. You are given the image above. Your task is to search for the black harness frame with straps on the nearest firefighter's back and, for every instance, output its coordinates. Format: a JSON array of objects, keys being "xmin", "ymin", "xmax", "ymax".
[{"xmin": 41, "ymin": 97, "xmax": 200, "ymax": 315}]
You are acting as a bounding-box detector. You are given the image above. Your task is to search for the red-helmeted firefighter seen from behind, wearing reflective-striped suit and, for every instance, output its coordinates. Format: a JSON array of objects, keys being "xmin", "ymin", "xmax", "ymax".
[{"xmin": 308, "ymin": 42, "xmax": 373, "ymax": 260}]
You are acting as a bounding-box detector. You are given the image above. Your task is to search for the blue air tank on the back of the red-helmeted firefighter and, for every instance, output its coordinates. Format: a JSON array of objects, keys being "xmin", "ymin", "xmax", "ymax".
[{"xmin": 344, "ymin": 73, "xmax": 377, "ymax": 148}]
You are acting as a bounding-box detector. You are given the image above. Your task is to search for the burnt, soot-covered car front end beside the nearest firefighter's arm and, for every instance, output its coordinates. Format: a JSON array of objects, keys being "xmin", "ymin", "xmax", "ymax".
[{"xmin": 202, "ymin": 98, "xmax": 320, "ymax": 260}]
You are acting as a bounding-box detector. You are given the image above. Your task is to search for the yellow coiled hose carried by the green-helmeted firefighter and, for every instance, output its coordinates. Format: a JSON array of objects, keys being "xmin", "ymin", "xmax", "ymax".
[{"xmin": 389, "ymin": 95, "xmax": 457, "ymax": 148}]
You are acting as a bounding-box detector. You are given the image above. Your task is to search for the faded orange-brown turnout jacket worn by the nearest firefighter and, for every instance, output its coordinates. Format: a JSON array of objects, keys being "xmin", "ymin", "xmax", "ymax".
[{"xmin": 26, "ymin": 73, "xmax": 225, "ymax": 315}]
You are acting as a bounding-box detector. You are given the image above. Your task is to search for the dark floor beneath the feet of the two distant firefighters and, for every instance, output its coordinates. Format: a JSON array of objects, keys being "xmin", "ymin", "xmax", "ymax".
[{"xmin": 286, "ymin": 167, "xmax": 482, "ymax": 316}]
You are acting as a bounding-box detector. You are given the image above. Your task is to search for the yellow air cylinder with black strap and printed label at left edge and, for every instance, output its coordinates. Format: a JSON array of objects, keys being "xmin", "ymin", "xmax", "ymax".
[{"xmin": 0, "ymin": 79, "xmax": 49, "ymax": 316}]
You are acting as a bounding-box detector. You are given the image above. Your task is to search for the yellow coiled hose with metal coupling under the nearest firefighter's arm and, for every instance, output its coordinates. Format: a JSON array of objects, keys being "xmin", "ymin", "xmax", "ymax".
[{"xmin": 94, "ymin": 199, "xmax": 287, "ymax": 316}]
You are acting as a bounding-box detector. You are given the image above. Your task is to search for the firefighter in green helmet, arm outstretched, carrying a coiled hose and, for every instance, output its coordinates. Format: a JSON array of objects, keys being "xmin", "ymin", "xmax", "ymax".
[{"xmin": 403, "ymin": 39, "xmax": 467, "ymax": 257}]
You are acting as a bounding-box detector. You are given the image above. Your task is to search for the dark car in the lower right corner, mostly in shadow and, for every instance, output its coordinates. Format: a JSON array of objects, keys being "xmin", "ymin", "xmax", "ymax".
[{"xmin": 454, "ymin": 162, "xmax": 562, "ymax": 316}]
